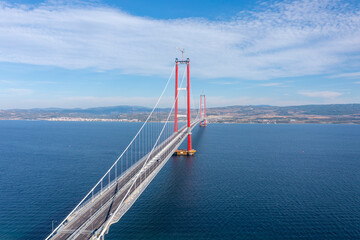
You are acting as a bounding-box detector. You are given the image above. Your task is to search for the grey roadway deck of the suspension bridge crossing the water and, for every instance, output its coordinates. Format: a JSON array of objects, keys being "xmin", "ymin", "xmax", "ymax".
[{"xmin": 51, "ymin": 121, "xmax": 199, "ymax": 240}]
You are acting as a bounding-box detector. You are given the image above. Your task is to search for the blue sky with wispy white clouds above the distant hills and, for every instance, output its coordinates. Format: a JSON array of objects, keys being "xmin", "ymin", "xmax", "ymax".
[{"xmin": 0, "ymin": 0, "xmax": 360, "ymax": 109}]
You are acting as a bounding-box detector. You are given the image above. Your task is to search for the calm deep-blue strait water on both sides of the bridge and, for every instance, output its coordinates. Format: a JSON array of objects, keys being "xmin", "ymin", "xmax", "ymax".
[{"xmin": 0, "ymin": 121, "xmax": 360, "ymax": 240}]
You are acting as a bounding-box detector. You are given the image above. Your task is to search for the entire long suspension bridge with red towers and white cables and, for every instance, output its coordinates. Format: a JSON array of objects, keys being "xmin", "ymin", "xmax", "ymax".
[{"xmin": 46, "ymin": 58, "xmax": 207, "ymax": 240}]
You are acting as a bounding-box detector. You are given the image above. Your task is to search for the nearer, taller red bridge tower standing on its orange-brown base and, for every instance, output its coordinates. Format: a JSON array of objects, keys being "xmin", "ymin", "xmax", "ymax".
[{"xmin": 174, "ymin": 58, "xmax": 196, "ymax": 156}]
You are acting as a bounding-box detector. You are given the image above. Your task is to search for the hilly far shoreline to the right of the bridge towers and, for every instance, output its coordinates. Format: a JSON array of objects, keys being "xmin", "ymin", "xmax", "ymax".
[{"xmin": 207, "ymin": 104, "xmax": 360, "ymax": 124}]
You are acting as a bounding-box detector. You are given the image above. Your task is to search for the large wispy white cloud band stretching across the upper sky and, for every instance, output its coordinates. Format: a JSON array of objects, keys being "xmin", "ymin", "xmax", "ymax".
[{"xmin": 0, "ymin": 0, "xmax": 360, "ymax": 79}]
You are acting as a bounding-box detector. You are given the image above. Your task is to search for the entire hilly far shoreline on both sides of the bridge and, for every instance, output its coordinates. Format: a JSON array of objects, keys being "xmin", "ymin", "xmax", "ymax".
[{"xmin": 0, "ymin": 104, "xmax": 360, "ymax": 124}]
